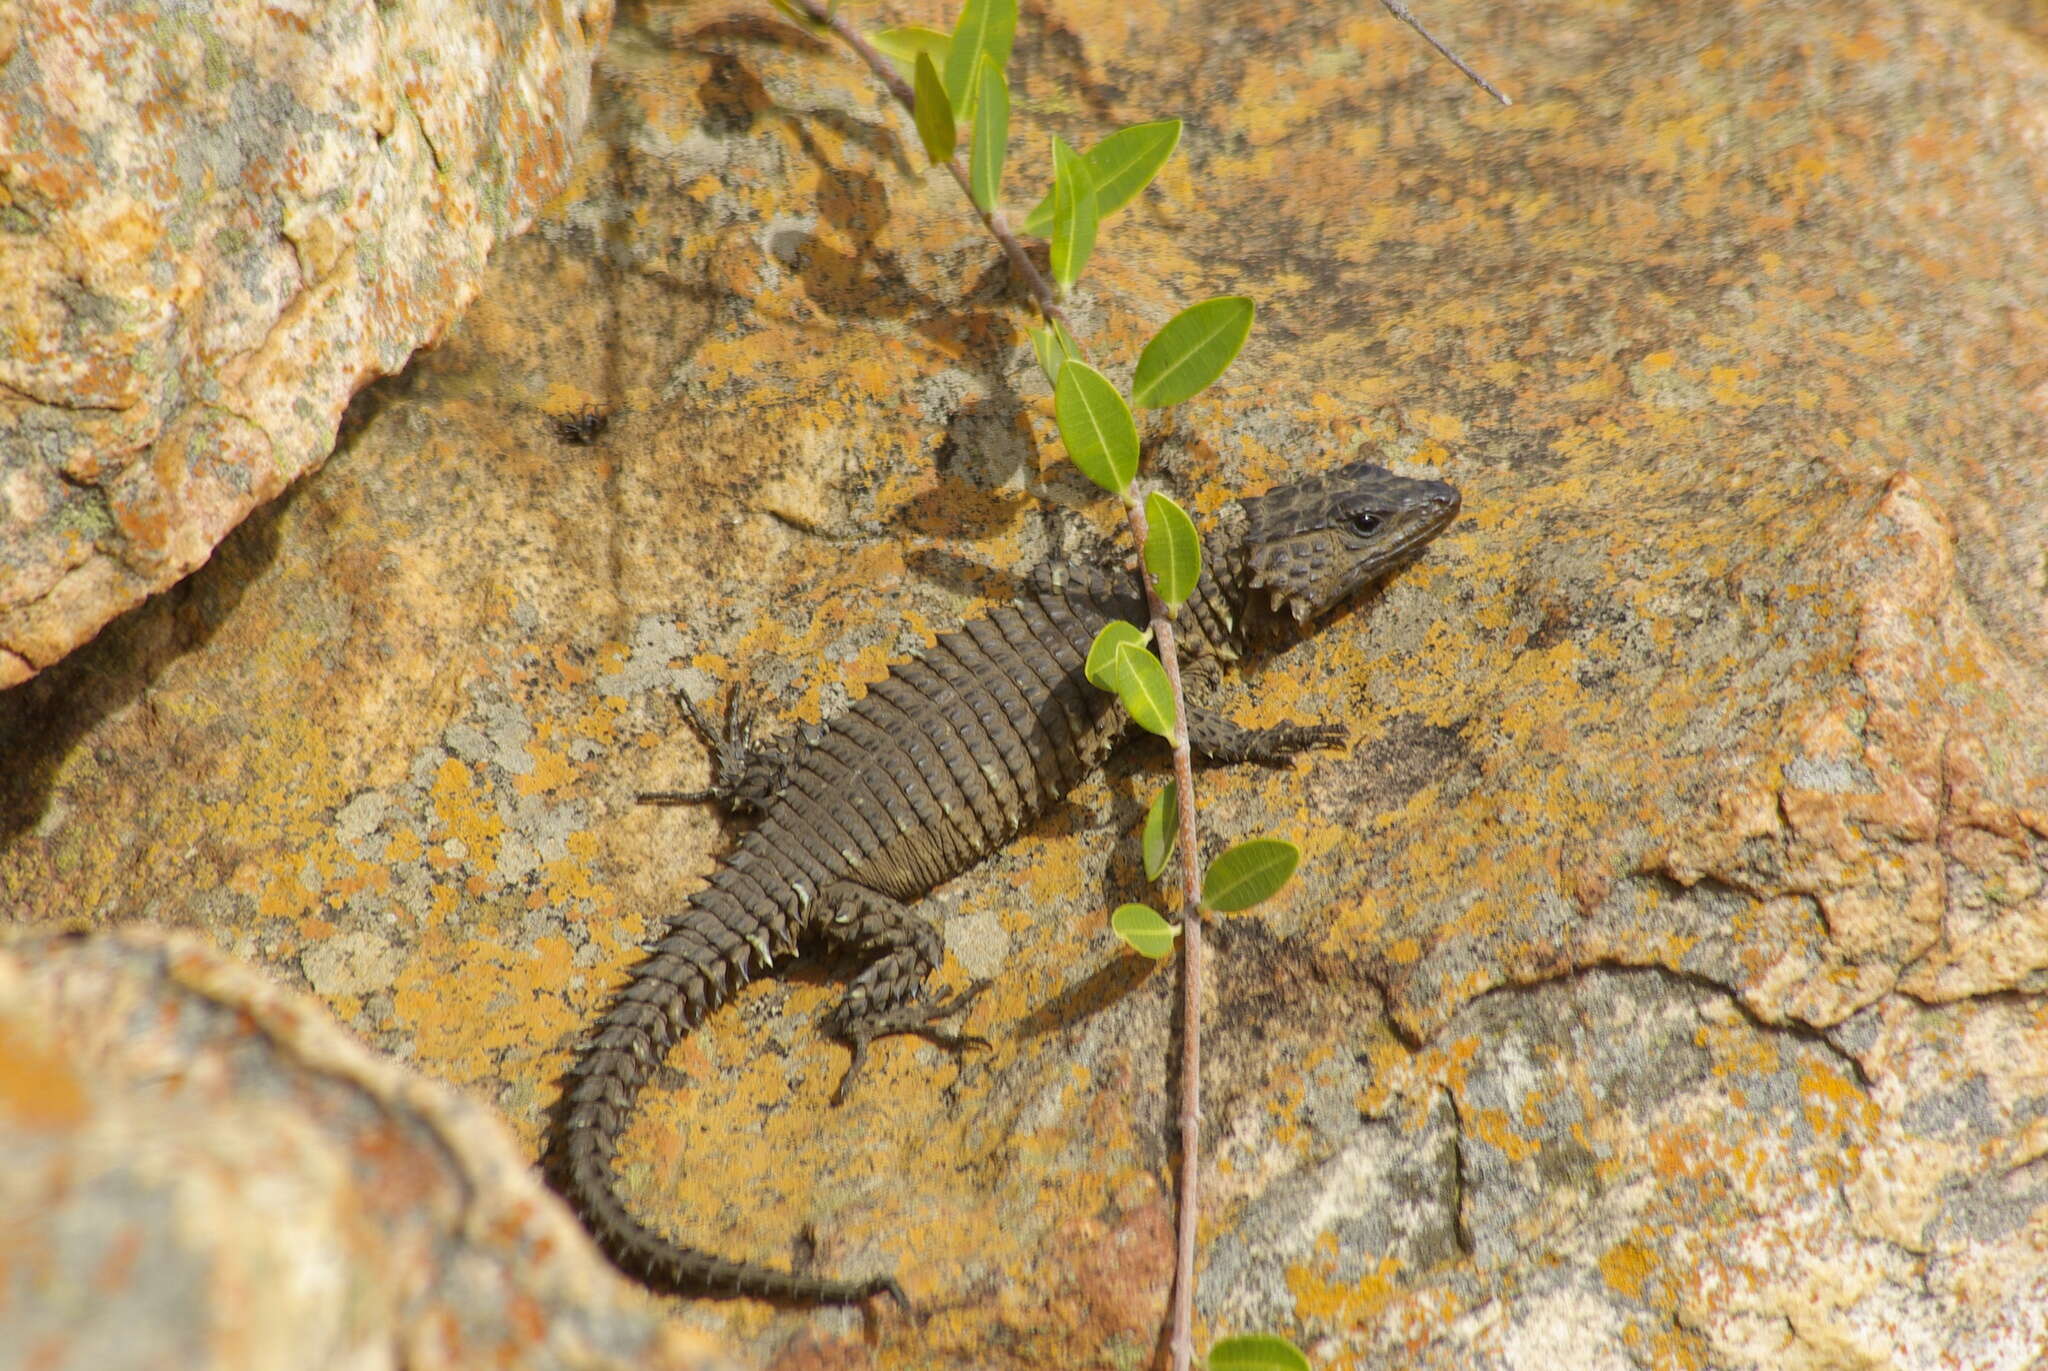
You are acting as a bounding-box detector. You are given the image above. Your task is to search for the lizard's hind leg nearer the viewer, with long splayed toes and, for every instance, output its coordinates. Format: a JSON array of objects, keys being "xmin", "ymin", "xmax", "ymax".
[{"xmin": 819, "ymin": 881, "xmax": 987, "ymax": 1105}]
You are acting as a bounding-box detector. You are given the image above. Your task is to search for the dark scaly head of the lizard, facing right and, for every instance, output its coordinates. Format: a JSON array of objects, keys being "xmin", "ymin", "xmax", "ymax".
[{"xmin": 1243, "ymin": 461, "xmax": 1458, "ymax": 623}]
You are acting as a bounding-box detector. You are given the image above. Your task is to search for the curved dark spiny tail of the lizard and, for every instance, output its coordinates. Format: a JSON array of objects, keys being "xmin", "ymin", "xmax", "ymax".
[{"xmin": 549, "ymin": 891, "xmax": 903, "ymax": 1303}]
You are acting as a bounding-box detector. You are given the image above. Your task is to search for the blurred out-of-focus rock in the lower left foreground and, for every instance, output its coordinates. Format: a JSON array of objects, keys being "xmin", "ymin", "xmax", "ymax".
[{"xmin": 0, "ymin": 932, "xmax": 731, "ymax": 1371}]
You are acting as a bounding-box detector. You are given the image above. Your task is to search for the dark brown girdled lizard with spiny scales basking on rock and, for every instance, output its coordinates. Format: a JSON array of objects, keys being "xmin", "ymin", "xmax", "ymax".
[{"xmin": 549, "ymin": 461, "xmax": 1458, "ymax": 1303}]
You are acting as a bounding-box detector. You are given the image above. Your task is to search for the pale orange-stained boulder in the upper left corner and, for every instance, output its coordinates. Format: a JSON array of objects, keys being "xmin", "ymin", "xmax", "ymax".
[{"xmin": 0, "ymin": 0, "xmax": 612, "ymax": 689}]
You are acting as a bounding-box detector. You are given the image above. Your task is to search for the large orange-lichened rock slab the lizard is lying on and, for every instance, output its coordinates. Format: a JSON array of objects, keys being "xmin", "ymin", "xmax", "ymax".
[{"xmin": 0, "ymin": 0, "xmax": 2048, "ymax": 1371}]
